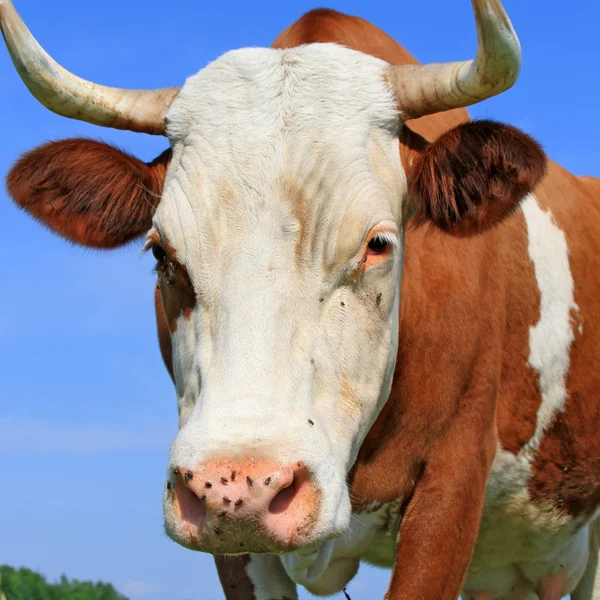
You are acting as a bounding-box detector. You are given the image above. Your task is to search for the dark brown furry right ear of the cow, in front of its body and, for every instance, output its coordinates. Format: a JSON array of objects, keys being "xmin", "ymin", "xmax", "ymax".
[{"xmin": 408, "ymin": 121, "xmax": 546, "ymax": 237}]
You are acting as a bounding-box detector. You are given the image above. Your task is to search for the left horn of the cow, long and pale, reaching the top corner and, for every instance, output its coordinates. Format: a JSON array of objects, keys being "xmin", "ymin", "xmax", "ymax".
[{"xmin": 0, "ymin": 0, "xmax": 179, "ymax": 135}]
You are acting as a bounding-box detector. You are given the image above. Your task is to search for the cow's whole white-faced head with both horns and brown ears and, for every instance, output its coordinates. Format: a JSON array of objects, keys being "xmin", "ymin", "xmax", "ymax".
[{"xmin": 0, "ymin": 0, "xmax": 544, "ymax": 571}]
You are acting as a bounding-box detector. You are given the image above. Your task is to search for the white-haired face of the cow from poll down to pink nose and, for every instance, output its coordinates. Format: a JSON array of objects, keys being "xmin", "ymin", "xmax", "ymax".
[{"xmin": 154, "ymin": 44, "xmax": 406, "ymax": 535}]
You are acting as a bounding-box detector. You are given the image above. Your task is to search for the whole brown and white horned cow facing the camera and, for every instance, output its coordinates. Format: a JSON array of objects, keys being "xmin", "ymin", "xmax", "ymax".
[{"xmin": 0, "ymin": 0, "xmax": 600, "ymax": 600}]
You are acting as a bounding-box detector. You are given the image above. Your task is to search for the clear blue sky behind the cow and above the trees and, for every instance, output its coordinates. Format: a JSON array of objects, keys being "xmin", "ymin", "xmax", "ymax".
[{"xmin": 0, "ymin": 0, "xmax": 600, "ymax": 600}]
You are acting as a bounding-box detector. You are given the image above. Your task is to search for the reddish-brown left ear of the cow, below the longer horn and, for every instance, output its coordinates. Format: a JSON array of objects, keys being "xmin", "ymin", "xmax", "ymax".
[{"xmin": 7, "ymin": 139, "xmax": 171, "ymax": 248}]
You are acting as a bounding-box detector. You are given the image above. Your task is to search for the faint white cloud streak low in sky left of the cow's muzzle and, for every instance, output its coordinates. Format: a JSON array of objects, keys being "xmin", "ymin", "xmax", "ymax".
[{"xmin": 0, "ymin": 416, "xmax": 174, "ymax": 456}]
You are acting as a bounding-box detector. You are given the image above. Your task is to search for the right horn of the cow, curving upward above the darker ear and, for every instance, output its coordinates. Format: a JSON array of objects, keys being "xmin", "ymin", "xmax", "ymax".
[{"xmin": 387, "ymin": 0, "xmax": 521, "ymax": 119}]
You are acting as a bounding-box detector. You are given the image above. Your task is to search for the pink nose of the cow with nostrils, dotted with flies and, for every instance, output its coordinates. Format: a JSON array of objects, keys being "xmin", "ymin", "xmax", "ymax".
[{"xmin": 165, "ymin": 459, "xmax": 320, "ymax": 554}]
